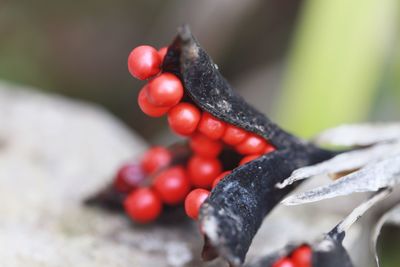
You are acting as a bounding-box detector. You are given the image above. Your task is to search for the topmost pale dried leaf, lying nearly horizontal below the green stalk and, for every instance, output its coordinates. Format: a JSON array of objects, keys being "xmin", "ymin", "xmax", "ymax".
[{"xmin": 314, "ymin": 122, "xmax": 400, "ymax": 146}]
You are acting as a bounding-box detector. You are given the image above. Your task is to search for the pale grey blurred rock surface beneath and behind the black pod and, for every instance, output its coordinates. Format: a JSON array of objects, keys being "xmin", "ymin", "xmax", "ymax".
[{"xmin": 0, "ymin": 83, "xmax": 368, "ymax": 267}]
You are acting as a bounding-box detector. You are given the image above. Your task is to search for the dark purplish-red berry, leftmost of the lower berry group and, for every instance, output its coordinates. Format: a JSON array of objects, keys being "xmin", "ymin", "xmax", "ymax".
[{"xmin": 114, "ymin": 163, "xmax": 145, "ymax": 193}]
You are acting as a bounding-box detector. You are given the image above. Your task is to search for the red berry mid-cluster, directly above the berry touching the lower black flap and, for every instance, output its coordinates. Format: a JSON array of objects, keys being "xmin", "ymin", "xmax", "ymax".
[{"xmin": 187, "ymin": 156, "xmax": 222, "ymax": 188}]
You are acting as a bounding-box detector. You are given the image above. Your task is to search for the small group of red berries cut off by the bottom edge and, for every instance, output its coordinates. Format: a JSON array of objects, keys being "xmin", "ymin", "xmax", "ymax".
[{"xmin": 272, "ymin": 245, "xmax": 312, "ymax": 267}]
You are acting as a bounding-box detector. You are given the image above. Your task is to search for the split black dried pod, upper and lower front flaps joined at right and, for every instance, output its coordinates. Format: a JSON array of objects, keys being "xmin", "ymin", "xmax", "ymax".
[{"xmin": 163, "ymin": 26, "xmax": 335, "ymax": 266}]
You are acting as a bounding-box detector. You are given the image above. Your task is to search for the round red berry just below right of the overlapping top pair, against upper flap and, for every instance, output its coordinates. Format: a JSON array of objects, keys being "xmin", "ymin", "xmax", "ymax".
[{"xmin": 168, "ymin": 103, "xmax": 201, "ymax": 135}]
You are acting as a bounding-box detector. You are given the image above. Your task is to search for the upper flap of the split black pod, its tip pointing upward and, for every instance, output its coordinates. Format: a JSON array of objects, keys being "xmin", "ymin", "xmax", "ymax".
[{"xmin": 163, "ymin": 26, "xmax": 302, "ymax": 149}]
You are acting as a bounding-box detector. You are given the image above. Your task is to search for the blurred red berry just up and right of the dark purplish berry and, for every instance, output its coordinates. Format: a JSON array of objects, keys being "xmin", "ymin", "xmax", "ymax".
[{"xmin": 141, "ymin": 146, "xmax": 172, "ymax": 174}]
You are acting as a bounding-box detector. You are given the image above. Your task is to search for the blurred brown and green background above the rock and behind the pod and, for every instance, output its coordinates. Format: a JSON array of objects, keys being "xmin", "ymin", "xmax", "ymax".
[{"xmin": 0, "ymin": 0, "xmax": 400, "ymax": 266}]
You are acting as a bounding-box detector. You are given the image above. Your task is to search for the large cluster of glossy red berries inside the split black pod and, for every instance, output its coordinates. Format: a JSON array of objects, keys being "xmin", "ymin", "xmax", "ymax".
[{"xmin": 115, "ymin": 45, "xmax": 275, "ymax": 223}]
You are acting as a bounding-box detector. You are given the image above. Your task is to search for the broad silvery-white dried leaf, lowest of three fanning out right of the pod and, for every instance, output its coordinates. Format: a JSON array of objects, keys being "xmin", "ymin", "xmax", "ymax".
[{"xmin": 282, "ymin": 154, "xmax": 400, "ymax": 205}]
